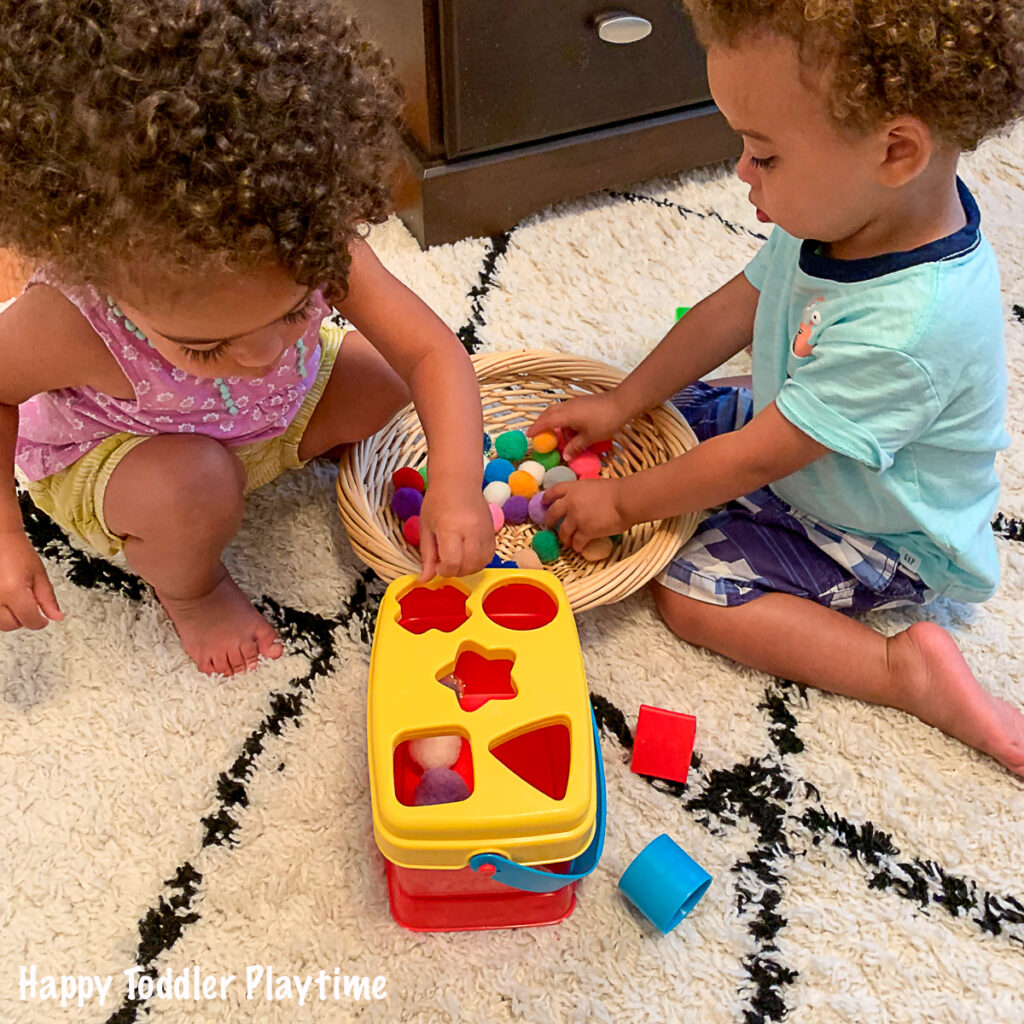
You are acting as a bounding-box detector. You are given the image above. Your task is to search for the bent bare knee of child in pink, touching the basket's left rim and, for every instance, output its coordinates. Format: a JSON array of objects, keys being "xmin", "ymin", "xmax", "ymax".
[{"xmin": 299, "ymin": 331, "xmax": 410, "ymax": 460}]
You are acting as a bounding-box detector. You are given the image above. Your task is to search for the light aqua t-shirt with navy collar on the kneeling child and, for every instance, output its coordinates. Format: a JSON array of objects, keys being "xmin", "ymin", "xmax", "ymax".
[{"xmin": 745, "ymin": 182, "xmax": 1009, "ymax": 601}]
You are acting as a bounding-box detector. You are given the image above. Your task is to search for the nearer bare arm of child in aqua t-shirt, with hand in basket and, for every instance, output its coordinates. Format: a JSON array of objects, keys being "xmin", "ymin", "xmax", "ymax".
[{"xmin": 547, "ymin": 402, "xmax": 829, "ymax": 550}]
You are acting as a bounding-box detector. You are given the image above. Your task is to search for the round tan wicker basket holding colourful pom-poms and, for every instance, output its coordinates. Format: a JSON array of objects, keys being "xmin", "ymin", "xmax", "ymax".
[{"xmin": 338, "ymin": 350, "xmax": 697, "ymax": 611}]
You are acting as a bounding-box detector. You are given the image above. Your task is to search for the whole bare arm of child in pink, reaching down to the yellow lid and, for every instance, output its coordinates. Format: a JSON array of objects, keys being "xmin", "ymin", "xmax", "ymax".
[{"xmin": 338, "ymin": 242, "xmax": 494, "ymax": 579}]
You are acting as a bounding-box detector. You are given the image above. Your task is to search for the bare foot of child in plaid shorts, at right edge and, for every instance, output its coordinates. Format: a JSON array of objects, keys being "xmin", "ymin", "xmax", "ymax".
[{"xmin": 888, "ymin": 623, "xmax": 1024, "ymax": 777}]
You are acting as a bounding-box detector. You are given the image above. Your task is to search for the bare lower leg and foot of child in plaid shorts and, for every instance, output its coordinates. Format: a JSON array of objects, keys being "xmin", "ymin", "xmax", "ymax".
[{"xmin": 653, "ymin": 584, "xmax": 1024, "ymax": 776}]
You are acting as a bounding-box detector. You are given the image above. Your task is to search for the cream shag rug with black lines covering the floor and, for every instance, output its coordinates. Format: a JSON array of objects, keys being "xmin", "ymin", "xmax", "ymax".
[{"xmin": 6, "ymin": 131, "xmax": 1024, "ymax": 1024}]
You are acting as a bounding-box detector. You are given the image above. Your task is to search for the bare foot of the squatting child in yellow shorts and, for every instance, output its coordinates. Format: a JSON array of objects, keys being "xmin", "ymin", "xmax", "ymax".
[{"xmin": 157, "ymin": 569, "xmax": 283, "ymax": 676}]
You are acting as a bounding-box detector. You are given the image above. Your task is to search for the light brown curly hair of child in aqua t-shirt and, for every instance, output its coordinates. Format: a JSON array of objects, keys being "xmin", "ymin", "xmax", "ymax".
[{"xmin": 684, "ymin": 0, "xmax": 1024, "ymax": 150}]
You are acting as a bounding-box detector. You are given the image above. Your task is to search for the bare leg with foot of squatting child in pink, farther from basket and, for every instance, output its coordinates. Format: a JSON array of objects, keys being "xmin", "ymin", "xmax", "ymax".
[{"xmin": 103, "ymin": 434, "xmax": 282, "ymax": 676}]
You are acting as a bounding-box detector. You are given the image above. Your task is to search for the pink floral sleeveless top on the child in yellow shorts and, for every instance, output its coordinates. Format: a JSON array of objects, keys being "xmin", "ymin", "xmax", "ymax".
[{"xmin": 14, "ymin": 272, "xmax": 331, "ymax": 480}]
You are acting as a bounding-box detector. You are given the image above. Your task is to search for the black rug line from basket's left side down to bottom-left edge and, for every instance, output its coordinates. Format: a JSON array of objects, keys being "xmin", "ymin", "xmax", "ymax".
[{"xmin": 106, "ymin": 569, "xmax": 384, "ymax": 1024}]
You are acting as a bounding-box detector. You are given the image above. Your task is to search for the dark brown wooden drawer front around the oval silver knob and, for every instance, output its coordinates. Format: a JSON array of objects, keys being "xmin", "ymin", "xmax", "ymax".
[{"xmin": 438, "ymin": 0, "xmax": 710, "ymax": 158}]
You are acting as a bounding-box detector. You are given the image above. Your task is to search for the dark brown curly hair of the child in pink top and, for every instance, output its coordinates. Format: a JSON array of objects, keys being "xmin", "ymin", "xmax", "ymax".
[{"xmin": 0, "ymin": 0, "xmax": 398, "ymax": 293}]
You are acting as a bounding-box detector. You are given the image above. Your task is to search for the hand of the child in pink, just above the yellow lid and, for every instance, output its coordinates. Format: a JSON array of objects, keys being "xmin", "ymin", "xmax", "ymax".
[{"xmin": 420, "ymin": 477, "xmax": 495, "ymax": 583}]
